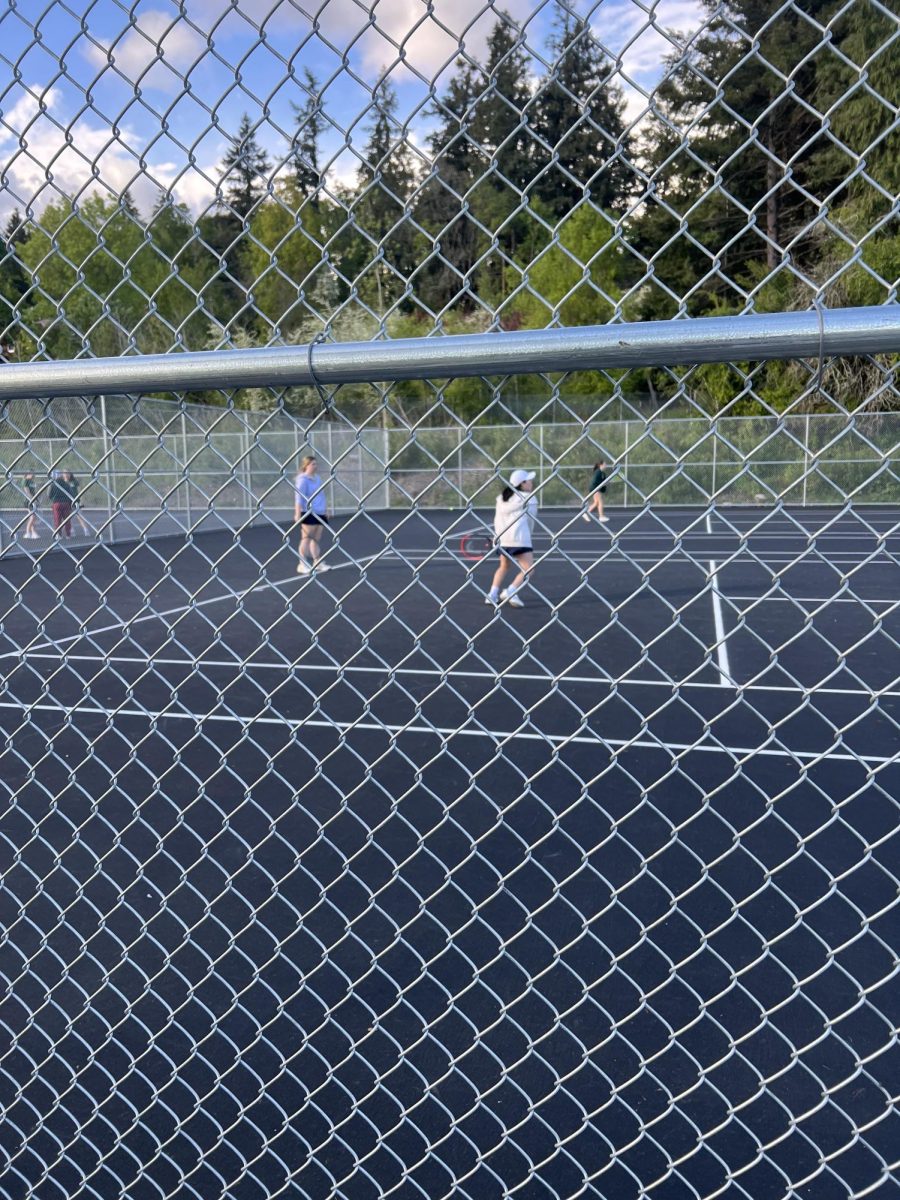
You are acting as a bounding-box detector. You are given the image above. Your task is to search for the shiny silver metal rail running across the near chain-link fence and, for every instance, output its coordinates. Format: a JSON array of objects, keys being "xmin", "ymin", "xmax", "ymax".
[{"xmin": 0, "ymin": 305, "xmax": 900, "ymax": 401}]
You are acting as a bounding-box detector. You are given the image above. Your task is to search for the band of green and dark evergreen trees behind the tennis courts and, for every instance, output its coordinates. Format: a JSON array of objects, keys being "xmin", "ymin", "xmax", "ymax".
[{"xmin": 0, "ymin": 0, "xmax": 900, "ymax": 409}]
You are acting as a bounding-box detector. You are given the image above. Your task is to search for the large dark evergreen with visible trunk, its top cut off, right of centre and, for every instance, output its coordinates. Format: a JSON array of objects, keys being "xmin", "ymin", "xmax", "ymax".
[{"xmin": 634, "ymin": 0, "xmax": 838, "ymax": 316}]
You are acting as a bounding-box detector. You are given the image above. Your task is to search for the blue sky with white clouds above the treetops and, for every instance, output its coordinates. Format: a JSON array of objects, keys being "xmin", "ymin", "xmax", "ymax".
[{"xmin": 0, "ymin": 0, "xmax": 702, "ymax": 224}]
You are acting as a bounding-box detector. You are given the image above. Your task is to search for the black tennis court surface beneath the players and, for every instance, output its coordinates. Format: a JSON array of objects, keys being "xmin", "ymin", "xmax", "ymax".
[{"xmin": 0, "ymin": 508, "xmax": 900, "ymax": 1200}]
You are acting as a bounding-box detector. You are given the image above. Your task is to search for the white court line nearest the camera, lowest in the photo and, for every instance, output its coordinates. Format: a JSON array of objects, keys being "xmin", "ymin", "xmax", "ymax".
[{"xmin": 0, "ymin": 701, "xmax": 900, "ymax": 766}]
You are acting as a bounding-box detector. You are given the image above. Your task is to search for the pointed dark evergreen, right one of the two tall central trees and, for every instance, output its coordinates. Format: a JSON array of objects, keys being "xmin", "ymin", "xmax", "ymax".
[{"xmin": 533, "ymin": 10, "xmax": 630, "ymax": 217}]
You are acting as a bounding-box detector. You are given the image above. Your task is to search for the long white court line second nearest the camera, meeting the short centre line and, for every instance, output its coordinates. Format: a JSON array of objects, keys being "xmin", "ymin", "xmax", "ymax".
[{"xmin": 22, "ymin": 650, "xmax": 900, "ymax": 698}]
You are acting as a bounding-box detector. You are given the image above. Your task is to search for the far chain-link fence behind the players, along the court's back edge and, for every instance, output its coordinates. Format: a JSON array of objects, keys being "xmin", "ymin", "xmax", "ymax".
[{"xmin": 0, "ymin": 397, "xmax": 900, "ymax": 552}]
